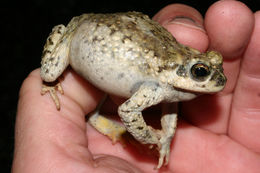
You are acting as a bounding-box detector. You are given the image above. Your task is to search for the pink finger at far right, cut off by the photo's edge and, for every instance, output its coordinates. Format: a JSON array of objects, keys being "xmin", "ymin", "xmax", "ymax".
[{"xmin": 229, "ymin": 11, "xmax": 260, "ymax": 152}]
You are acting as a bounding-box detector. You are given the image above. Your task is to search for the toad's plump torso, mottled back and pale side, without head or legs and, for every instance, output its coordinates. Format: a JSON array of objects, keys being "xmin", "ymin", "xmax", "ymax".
[{"xmin": 68, "ymin": 12, "xmax": 181, "ymax": 97}]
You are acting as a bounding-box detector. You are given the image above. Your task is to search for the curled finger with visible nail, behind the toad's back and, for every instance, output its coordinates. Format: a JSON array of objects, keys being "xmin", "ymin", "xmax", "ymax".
[{"xmin": 153, "ymin": 4, "xmax": 208, "ymax": 52}]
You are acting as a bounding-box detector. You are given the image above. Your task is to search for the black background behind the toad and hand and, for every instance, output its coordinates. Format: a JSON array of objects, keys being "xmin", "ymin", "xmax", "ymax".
[{"xmin": 0, "ymin": 0, "xmax": 260, "ymax": 172}]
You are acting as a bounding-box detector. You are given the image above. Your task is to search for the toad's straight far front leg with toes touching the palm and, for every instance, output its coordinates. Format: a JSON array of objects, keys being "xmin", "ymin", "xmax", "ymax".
[{"xmin": 156, "ymin": 114, "xmax": 177, "ymax": 169}]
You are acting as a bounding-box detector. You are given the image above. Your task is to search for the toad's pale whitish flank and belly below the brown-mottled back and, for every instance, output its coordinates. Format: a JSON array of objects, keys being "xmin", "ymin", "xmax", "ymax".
[{"xmin": 69, "ymin": 31, "xmax": 154, "ymax": 97}]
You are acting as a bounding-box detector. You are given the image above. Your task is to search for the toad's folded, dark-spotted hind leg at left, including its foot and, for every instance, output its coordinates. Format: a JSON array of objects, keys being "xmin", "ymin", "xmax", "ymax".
[{"xmin": 41, "ymin": 25, "xmax": 70, "ymax": 110}]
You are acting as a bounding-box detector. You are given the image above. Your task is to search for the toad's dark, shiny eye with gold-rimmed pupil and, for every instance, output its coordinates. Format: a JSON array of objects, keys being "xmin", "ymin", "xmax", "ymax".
[{"xmin": 191, "ymin": 63, "xmax": 210, "ymax": 81}]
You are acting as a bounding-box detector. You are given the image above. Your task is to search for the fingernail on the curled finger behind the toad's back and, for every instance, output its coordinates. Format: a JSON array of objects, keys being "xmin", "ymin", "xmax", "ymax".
[{"xmin": 164, "ymin": 16, "xmax": 205, "ymax": 32}]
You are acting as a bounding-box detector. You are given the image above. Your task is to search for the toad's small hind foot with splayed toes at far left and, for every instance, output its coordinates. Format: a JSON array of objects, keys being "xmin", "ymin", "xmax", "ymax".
[{"xmin": 41, "ymin": 82, "xmax": 64, "ymax": 110}]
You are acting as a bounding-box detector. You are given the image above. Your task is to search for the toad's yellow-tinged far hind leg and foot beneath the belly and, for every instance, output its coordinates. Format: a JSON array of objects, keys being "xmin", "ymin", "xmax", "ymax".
[{"xmin": 88, "ymin": 96, "xmax": 126, "ymax": 144}]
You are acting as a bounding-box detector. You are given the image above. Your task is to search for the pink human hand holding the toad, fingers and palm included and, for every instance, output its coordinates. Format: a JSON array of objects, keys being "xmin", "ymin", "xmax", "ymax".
[{"xmin": 12, "ymin": 1, "xmax": 260, "ymax": 173}]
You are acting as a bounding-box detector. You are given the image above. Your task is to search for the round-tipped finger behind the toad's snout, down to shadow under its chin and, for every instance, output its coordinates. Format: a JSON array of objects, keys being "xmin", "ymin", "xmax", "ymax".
[{"xmin": 181, "ymin": 1, "xmax": 254, "ymax": 134}]
